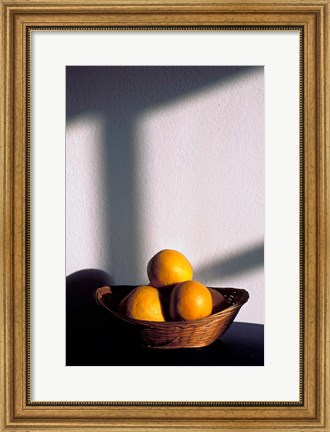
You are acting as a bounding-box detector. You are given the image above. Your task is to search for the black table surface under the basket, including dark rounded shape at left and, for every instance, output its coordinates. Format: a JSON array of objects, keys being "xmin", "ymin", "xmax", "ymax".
[{"xmin": 66, "ymin": 270, "xmax": 264, "ymax": 366}]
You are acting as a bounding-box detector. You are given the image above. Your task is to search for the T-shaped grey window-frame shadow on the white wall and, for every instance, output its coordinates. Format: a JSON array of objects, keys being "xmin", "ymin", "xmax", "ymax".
[{"xmin": 66, "ymin": 66, "xmax": 258, "ymax": 275}]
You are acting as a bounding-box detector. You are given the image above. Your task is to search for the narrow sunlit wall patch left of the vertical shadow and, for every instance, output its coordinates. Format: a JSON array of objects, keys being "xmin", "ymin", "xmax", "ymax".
[{"xmin": 66, "ymin": 113, "xmax": 109, "ymax": 274}]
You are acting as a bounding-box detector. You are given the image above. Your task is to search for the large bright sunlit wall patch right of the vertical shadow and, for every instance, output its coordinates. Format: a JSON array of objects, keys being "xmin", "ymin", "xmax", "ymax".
[{"xmin": 136, "ymin": 72, "xmax": 264, "ymax": 320}]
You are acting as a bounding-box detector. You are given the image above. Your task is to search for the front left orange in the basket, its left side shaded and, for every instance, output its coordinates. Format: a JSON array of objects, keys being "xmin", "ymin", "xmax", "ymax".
[{"xmin": 119, "ymin": 285, "xmax": 165, "ymax": 321}]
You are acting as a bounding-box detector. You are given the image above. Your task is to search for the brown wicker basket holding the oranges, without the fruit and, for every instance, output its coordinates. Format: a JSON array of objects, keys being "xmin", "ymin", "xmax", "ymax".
[{"xmin": 95, "ymin": 285, "xmax": 249, "ymax": 349}]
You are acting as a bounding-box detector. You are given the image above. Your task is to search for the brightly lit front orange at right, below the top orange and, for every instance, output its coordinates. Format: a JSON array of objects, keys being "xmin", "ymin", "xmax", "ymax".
[{"xmin": 169, "ymin": 281, "xmax": 212, "ymax": 321}]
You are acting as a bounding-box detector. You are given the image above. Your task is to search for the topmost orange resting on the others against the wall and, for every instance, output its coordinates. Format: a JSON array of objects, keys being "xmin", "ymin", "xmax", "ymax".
[{"xmin": 147, "ymin": 249, "xmax": 193, "ymax": 288}]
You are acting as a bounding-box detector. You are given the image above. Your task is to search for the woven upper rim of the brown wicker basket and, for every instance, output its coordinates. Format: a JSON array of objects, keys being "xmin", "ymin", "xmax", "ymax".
[{"xmin": 94, "ymin": 285, "xmax": 249, "ymax": 329}]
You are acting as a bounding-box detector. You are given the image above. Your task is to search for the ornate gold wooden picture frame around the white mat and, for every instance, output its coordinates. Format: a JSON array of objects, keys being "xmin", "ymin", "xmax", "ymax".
[{"xmin": 0, "ymin": 0, "xmax": 330, "ymax": 432}]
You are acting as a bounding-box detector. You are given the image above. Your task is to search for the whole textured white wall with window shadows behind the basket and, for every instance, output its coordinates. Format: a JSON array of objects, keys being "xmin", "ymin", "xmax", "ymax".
[{"xmin": 66, "ymin": 67, "xmax": 264, "ymax": 323}]
